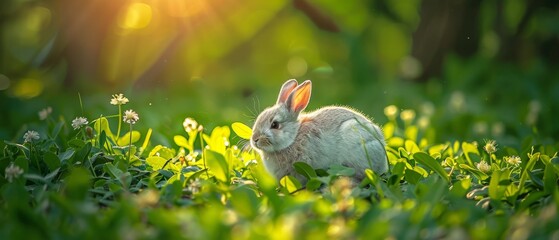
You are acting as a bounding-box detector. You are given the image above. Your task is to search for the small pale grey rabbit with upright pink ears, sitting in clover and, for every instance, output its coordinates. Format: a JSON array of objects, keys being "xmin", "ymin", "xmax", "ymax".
[{"xmin": 250, "ymin": 79, "xmax": 388, "ymax": 183}]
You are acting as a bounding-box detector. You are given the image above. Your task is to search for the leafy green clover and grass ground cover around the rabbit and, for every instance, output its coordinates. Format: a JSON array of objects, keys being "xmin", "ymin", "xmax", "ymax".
[{"xmin": 0, "ymin": 93, "xmax": 559, "ymax": 239}]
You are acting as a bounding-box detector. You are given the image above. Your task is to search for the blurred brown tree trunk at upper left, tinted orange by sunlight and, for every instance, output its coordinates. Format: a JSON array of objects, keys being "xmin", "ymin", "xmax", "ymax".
[{"xmin": 48, "ymin": 0, "xmax": 126, "ymax": 87}]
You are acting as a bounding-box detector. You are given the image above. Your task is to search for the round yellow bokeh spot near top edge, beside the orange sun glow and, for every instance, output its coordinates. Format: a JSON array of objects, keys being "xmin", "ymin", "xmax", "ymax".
[{"xmin": 118, "ymin": 3, "xmax": 153, "ymax": 29}]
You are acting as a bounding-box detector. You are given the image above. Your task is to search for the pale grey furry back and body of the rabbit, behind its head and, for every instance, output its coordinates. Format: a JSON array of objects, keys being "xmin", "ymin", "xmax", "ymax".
[{"xmin": 302, "ymin": 107, "xmax": 388, "ymax": 178}]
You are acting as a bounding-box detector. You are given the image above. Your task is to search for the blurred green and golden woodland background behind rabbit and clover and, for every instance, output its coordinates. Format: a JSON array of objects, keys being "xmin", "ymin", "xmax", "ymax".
[{"xmin": 0, "ymin": 0, "xmax": 559, "ymax": 145}]
